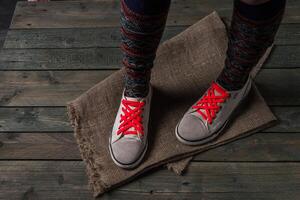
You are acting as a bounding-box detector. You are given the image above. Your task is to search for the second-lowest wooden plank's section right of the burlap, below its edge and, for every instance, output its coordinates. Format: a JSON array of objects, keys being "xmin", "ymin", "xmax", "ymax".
[{"xmin": 194, "ymin": 133, "xmax": 300, "ymax": 162}]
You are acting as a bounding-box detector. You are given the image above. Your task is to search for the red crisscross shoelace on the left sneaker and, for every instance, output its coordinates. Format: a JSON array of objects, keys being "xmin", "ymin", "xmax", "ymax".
[{"xmin": 117, "ymin": 99, "xmax": 145, "ymax": 135}]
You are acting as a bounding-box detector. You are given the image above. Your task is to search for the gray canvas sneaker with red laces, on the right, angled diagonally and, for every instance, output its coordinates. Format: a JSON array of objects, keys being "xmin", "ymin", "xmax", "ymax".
[{"xmin": 175, "ymin": 78, "xmax": 252, "ymax": 145}]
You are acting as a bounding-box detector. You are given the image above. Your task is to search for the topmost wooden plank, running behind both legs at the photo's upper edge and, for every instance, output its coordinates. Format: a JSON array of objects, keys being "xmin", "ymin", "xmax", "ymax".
[{"xmin": 11, "ymin": 0, "xmax": 300, "ymax": 29}]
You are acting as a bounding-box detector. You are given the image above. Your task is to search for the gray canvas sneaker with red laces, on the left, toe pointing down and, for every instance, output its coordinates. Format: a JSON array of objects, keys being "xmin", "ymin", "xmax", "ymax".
[{"xmin": 109, "ymin": 86, "xmax": 152, "ymax": 169}]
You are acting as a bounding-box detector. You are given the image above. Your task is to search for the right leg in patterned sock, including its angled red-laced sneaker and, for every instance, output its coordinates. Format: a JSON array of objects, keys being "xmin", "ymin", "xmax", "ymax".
[{"xmin": 175, "ymin": 0, "xmax": 285, "ymax": 145}]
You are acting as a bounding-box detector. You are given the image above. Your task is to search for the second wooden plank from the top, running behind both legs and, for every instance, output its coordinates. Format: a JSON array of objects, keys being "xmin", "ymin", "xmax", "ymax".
[{"xmin": 4, "ymin": 24, "xmax": 300, "ymax": 48}]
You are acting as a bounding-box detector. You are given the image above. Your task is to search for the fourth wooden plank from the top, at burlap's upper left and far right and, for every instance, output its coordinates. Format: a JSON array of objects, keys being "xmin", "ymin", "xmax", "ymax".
[{"xmin": 0, "ymin": 68, "xmax": 300, "ymax": 106}]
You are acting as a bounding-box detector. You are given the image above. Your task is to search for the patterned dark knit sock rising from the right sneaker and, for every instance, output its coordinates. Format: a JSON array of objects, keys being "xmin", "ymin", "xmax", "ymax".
[{"xmin": 217, "ymin": 0, "xmax": 285, "ymax": 91}]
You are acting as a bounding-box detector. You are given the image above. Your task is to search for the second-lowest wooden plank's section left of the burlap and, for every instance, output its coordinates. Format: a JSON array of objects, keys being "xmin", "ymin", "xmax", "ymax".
[{"xmin": 0, "ymin": 132, "xmax": 81, "ymax": 160}]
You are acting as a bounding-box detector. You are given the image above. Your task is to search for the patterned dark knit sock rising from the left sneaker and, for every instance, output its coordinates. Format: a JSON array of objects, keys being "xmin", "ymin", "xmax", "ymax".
[{"xmin": 121, "ymin": 0, "xmax": 170, "ymax": 97}]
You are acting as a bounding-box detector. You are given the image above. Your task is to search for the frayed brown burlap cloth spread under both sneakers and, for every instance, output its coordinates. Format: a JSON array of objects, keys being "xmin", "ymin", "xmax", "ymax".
[{"xmin": 68, "ymin": 12, "xmax": 275, "ymax": 196}]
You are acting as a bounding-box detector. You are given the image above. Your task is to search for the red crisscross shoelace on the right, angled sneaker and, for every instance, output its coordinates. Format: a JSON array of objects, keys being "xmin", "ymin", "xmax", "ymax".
[{"xmin": 192, "ymin": 82, "xmax": 230, "ymax": 124}]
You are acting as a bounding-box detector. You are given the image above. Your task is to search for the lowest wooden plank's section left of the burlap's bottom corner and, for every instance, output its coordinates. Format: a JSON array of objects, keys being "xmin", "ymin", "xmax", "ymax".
[{"xmin": 0, "ymin": 161, "xmax": 92, "ymax": 200}]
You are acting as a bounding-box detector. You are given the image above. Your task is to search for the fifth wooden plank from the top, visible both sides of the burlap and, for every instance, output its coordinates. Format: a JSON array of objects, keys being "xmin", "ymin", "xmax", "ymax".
[{"xmin": 0, "ymin": 106, "xmax": 300, "ymax": 133}]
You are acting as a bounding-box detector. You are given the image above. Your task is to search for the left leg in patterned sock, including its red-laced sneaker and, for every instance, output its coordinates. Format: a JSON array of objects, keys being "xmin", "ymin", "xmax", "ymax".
[{"xmin": 109, "ymin": 0, "xmax": 170, "ymax": 169}]
